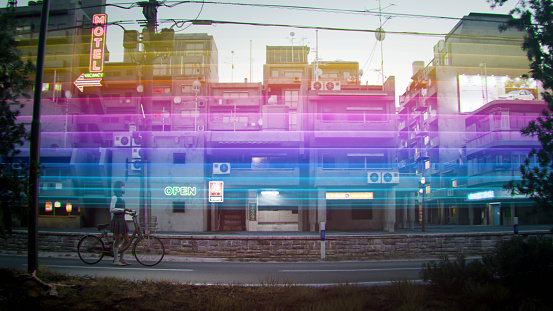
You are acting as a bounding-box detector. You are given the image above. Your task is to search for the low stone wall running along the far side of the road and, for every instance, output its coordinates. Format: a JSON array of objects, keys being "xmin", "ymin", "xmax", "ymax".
[{"xmin": 0, "ymin": 231, "xmax": 552, "ymax": 260}]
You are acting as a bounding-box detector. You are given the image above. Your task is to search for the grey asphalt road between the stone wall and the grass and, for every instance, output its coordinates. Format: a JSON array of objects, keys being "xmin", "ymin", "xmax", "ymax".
[{"xmin": 0, "ymin": 255, "xmax": 427, "ymax": 286}]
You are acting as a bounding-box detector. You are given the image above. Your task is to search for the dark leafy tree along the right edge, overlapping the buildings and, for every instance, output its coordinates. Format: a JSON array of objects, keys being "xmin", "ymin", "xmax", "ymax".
[{"xmin": 487, "ymin": 0, "xmax": 553, "ymax": 211}]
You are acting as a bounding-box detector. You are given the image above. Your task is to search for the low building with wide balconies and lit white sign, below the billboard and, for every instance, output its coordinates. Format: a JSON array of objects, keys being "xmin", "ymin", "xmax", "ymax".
[{"xmin": 464, "ymin": 99, "xmax": 553, "ymax": 226}]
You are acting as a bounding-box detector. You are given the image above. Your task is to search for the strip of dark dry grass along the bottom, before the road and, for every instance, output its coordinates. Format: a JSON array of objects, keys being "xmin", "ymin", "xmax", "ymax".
[{"xmin": 0, "ymin": 267, "xmax": 551, "ymax": 311}]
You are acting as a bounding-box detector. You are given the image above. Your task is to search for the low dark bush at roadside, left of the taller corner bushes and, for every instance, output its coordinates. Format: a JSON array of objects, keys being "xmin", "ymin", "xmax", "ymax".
[{"xmin": 420, "ymin": 254, "xmax": 492, "ymax": 292}]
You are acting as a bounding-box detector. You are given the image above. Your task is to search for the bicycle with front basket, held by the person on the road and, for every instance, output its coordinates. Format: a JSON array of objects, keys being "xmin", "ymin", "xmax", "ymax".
[{"xmin": 77, "ymin": 211, "xmax": 165, "ymax": 267}]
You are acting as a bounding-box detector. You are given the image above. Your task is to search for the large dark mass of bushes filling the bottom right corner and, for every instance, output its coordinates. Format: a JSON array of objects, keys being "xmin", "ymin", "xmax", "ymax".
[{"xmin": 421, "ymin": 236, "xmax": 553, "ymax": 310}]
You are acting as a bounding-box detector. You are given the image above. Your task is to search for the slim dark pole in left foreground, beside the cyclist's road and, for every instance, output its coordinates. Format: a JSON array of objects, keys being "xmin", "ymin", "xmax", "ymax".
[{"xmin": 27, "ymin": 0, "xmax": 50, "ymax": 273}]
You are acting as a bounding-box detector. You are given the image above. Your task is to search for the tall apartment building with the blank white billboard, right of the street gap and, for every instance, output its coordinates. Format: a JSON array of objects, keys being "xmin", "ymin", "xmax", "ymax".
[{"xmin": 398, "ymin": 13, "xmax": 540, "ymax": 224}]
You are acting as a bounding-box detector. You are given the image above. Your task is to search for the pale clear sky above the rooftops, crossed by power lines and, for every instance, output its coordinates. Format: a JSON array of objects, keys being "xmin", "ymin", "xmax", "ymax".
[{"xmin": 0, "ymin": 0, "xmax": 516, "ymax": 96}]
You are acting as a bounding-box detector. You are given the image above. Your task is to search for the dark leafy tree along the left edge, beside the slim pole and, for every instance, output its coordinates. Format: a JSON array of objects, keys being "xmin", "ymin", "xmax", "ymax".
[{"xmin": 0, "ymin": 13, "xmax": 34, "ymax": 235}]
